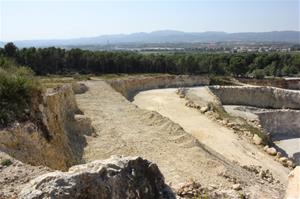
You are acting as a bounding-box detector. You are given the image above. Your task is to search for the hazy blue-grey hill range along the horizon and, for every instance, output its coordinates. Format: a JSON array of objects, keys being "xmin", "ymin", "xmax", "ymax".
[{"xmin": 0, "ymin": 30, "xmax": 300, "ymax": 47}]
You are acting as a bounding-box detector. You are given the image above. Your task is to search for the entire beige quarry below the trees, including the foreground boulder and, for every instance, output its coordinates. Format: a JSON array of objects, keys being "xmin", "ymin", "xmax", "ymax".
[{"xmin": 0, "ymin": 75, "xmax": 300, "ymax": 199}]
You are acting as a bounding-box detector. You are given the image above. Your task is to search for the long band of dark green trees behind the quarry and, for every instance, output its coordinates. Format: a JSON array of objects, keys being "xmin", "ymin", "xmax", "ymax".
[{"xmin": 0, "ymin": 43, "xmax": 300, "ymax": 77}]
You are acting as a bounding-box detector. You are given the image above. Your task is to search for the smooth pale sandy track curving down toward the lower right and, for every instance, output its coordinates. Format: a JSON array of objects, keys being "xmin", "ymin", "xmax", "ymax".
[{"xmin": 134, "ymin": 89, "xmax": 288, "ymax": 181}]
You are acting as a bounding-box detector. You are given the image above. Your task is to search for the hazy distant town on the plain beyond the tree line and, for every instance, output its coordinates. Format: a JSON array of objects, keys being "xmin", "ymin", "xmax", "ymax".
[{"xmin": 63, "ymin": 42, "xmax": 300, "ymax": 53}]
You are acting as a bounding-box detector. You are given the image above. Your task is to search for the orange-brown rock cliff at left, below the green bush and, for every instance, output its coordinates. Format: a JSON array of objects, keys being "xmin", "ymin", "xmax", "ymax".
[{"xmin": 0, "ymin": 85, "xmax": 90, "ymax": 170}]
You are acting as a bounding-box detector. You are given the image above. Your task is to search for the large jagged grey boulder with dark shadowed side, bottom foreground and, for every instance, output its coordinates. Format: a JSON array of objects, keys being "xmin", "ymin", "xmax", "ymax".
[{"xmin": 19, "ymin": 156, "xmax": 175, "ymax": 199}]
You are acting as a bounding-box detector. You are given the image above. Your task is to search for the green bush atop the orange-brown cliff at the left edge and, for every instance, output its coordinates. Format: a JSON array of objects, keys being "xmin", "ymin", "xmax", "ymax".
[{"xmin": 0, "ymin": 62, "xmax": 40, "ymax": 126}]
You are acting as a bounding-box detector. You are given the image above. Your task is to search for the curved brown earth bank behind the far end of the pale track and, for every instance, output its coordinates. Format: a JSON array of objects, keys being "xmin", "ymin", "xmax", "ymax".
[{"xmin": 107, "ymin": 75, "xmax": 210, "ymax": 100}]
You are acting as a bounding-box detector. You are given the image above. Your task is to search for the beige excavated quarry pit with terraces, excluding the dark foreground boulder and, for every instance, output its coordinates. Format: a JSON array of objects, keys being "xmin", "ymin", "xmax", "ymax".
[{"xmin": 0, "ymin": 75, "xmax": 300, "ymax": 198}]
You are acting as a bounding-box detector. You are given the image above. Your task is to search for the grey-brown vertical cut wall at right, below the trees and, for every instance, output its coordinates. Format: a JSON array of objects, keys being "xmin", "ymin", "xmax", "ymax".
[{"xmin": 210, "ymin": 86, "xmax": 300, "ymax": 109}]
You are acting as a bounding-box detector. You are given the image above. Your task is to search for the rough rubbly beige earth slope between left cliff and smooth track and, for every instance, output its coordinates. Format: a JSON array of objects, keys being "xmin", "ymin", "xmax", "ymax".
[{"xmin": 76, "ymin": 81, "xmax": 285, "ymax": 198}]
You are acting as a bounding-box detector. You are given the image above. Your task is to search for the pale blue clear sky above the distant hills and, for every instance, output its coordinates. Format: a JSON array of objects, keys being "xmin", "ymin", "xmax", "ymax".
[{"xmin": 0, "ymin": 0, "xmax": 300, "ymax": 41}]
